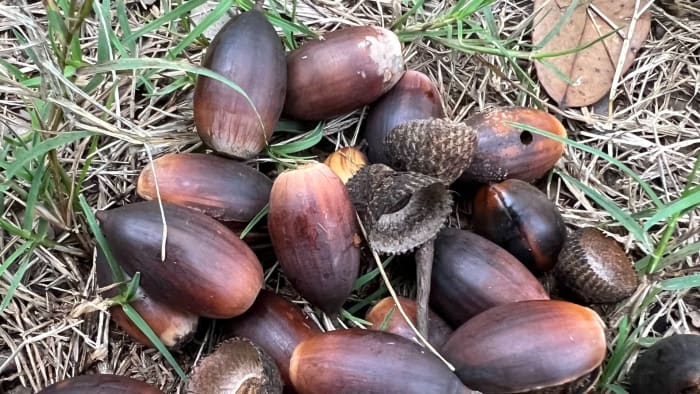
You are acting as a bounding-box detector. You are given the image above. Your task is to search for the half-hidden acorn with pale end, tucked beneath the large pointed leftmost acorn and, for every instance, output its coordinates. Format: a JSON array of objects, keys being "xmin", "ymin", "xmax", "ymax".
[{"xmin": 95, "ymin": 250, "xmax": 199, "ymax": 349}]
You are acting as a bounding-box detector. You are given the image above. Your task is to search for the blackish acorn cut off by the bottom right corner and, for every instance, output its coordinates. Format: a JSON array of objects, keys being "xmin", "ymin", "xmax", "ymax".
[{"xmin": 630, "ymin": 334, "xmax": 700, "ymax": 394}]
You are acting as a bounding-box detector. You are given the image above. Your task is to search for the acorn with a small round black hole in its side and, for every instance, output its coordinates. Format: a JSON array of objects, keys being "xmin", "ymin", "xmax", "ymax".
[{"xmin": 461, "ymin": 107, "xmax": 566, "ymax": 183}]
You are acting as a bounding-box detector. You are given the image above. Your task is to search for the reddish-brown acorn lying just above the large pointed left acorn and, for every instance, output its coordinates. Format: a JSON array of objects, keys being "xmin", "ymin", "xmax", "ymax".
[{"xmin": 136, "ymin": 153, "xmax": 272, "ymax": 222}]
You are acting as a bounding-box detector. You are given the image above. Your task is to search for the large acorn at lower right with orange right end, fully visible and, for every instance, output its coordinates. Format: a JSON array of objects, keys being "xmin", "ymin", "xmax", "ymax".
[{"xmin": 442, "ymin": 300, "xmax": 606, "ymax": 393}]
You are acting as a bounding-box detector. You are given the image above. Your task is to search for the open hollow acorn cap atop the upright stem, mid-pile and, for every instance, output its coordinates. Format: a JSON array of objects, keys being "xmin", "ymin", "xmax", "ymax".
[{"xmin": 347, "ymin": 164, "xmax": 452, "ymax": 254}]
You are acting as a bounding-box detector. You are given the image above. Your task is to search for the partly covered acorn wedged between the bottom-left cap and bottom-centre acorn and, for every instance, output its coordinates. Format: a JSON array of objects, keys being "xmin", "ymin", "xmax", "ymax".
[{"xmin": 222, "ymin": 290, "xmax": 321, "ymax": 386}]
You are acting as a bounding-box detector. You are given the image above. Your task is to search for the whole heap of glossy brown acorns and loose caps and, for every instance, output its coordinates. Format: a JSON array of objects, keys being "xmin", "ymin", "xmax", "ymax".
[{"xmin": 39, "ymin": 4, "xmax": 697, "ymax": 394}]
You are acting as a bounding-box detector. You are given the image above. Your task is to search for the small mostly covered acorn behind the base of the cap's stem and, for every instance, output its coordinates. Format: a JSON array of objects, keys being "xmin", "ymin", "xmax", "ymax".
[{"xmin": 365, "ymin": 297, "xmax": 452, "ymax": 348}]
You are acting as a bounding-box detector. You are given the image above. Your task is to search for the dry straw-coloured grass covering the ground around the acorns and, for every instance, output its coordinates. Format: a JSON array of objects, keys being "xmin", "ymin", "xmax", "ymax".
[{"xmin": 0, "ymin": 0, "xmax": 700, "ymax": 392}]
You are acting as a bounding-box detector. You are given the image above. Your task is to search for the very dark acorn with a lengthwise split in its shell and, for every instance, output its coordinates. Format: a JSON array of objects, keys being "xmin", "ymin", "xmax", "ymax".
[{"xmin": 473, "ymin": 179, "xmax": 566, "ymax": 272}]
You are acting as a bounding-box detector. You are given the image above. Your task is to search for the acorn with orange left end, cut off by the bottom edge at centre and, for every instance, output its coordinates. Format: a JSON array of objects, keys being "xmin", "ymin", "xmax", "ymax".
[{"xmin": 289, "ymin": 328, "xmax": 472, "ymax": 394}]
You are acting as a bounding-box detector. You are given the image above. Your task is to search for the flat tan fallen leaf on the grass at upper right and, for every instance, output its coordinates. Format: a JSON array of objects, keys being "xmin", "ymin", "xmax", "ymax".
[{"xmin": 532, "ymin": 0, "xmax": 651, "ymax": 107}]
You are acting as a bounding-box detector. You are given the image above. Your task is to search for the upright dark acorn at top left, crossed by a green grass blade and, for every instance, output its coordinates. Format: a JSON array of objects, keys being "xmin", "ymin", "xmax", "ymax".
[{"xmin": 193, "ymin": 7, "xmax": 287, "ymax": 159}]
